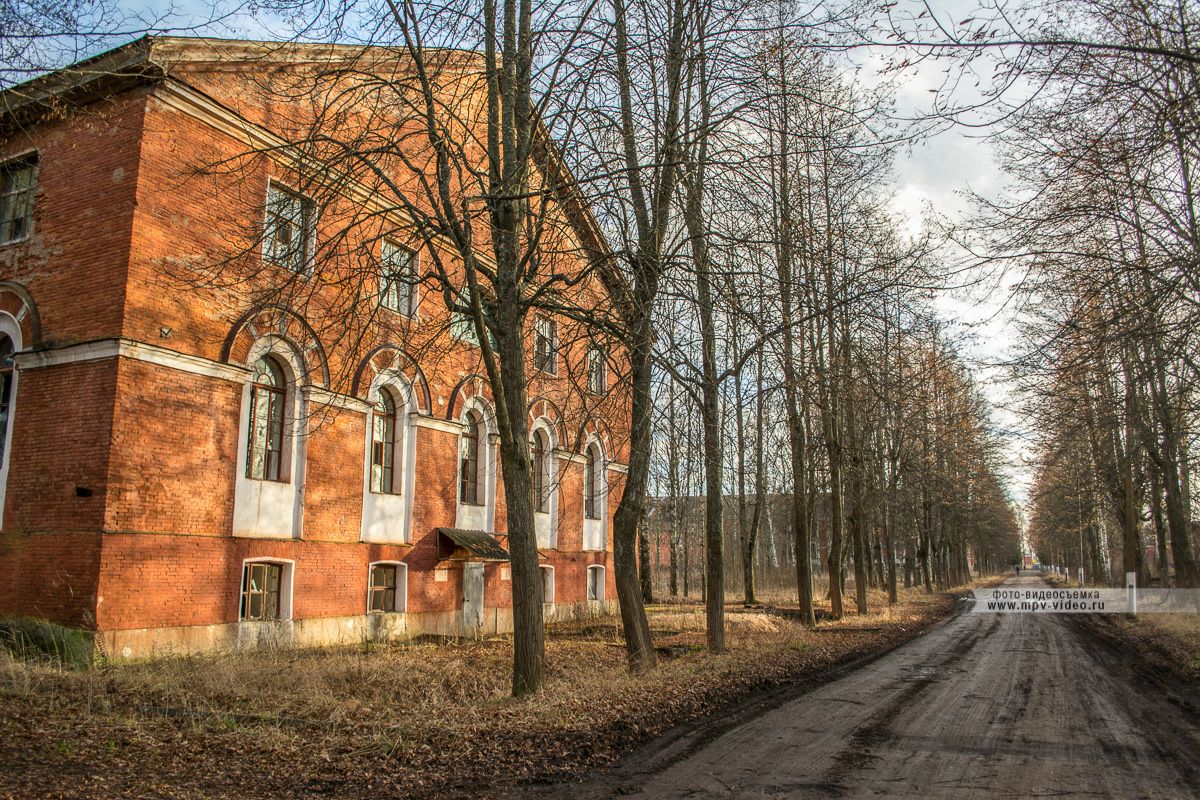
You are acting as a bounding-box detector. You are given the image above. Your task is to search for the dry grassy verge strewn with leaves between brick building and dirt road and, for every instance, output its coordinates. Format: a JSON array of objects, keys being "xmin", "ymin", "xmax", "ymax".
[{"xmin": 0, "ymin": 582, "xmax": 984, "ymax": 798}]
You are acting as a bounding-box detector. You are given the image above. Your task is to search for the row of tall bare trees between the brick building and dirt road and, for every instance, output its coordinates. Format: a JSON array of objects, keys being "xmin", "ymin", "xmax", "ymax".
[{"xmin": 18, "ymin": 0, "xmax": 1016, "ymax": 694}]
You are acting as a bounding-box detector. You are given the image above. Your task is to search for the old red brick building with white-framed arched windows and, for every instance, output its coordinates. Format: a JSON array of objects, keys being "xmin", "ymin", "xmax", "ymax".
[{"xmin": 0, "ymin": 38, "xmax": 628, "ymax": 656}]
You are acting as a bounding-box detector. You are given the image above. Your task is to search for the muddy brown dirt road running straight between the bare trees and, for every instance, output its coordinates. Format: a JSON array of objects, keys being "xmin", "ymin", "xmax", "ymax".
[{"xmin": 564, "ymin": 578, "xmax": 1200, "ymax": 800}]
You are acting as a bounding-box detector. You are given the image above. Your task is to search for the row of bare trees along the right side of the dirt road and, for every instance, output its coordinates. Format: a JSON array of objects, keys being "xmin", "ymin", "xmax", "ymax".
[{"xmin": 986, "ymin": 0, "xmax": 1200, "ymax": 587}]
